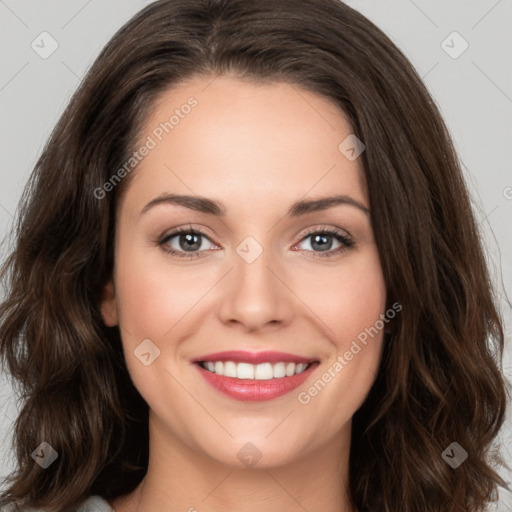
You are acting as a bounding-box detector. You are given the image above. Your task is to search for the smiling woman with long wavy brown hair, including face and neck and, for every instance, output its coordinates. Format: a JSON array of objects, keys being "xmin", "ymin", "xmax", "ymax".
[{"xmin": 0, "ymin": 0, "xmax": 506, "ymax": 512}]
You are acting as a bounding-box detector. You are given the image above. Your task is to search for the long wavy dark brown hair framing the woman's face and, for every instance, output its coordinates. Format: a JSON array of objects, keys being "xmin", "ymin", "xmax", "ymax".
[{"xmin": 0, "ymin": 0, "xmax": 506, "ymax": 512}]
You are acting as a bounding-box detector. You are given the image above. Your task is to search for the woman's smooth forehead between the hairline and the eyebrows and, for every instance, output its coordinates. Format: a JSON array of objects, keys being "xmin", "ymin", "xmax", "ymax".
[{"xmin": 120, "ymin": 76, "xmax": 367, "ymax": 213}]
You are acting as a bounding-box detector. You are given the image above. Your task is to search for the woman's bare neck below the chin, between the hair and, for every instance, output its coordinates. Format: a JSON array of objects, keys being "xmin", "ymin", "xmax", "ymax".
[{"xmin": 112, "ymin": 413, "xmax": 354, "ymax": 512}]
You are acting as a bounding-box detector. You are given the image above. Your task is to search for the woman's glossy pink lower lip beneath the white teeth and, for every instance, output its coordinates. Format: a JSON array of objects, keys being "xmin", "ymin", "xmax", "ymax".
[{"xmin": 195, "ymin": 362, "xmax": 319, "ymax": 402}]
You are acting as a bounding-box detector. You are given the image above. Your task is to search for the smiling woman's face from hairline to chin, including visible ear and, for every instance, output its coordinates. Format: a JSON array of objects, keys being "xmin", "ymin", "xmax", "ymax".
[{"xmin": 102, "ymin": 76, "xmax": 386, "ymax": 467}]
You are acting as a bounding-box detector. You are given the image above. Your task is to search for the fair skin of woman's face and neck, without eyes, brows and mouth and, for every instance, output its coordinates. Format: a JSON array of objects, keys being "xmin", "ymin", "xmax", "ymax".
[{"xmin": 101, "ymin": 76, "xmax": 386, "ymax": 512}]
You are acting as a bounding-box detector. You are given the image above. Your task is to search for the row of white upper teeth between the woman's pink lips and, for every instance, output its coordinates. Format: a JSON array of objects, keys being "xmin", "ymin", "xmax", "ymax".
[{"xmin": 201, "ymin": 361, "xmax": 309, "ymax": 380}]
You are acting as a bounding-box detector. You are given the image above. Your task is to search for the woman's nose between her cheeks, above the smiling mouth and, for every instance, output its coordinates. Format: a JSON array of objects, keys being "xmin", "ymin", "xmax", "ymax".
[{"xmin": 219, "ymin": 242, "xmax": 294, "ymax": 331}]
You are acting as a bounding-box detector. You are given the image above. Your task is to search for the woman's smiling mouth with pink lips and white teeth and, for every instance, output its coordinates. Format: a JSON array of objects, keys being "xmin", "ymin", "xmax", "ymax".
[{"xmin": 193, "ymin": 351, "xmax": 319, "ymax": 401}]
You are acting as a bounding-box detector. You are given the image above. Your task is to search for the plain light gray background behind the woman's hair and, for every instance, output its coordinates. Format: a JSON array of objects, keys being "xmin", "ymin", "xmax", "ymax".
[{"xmin": 0, "ymin": 0, "xmax": 512, "ymax": 511}]
